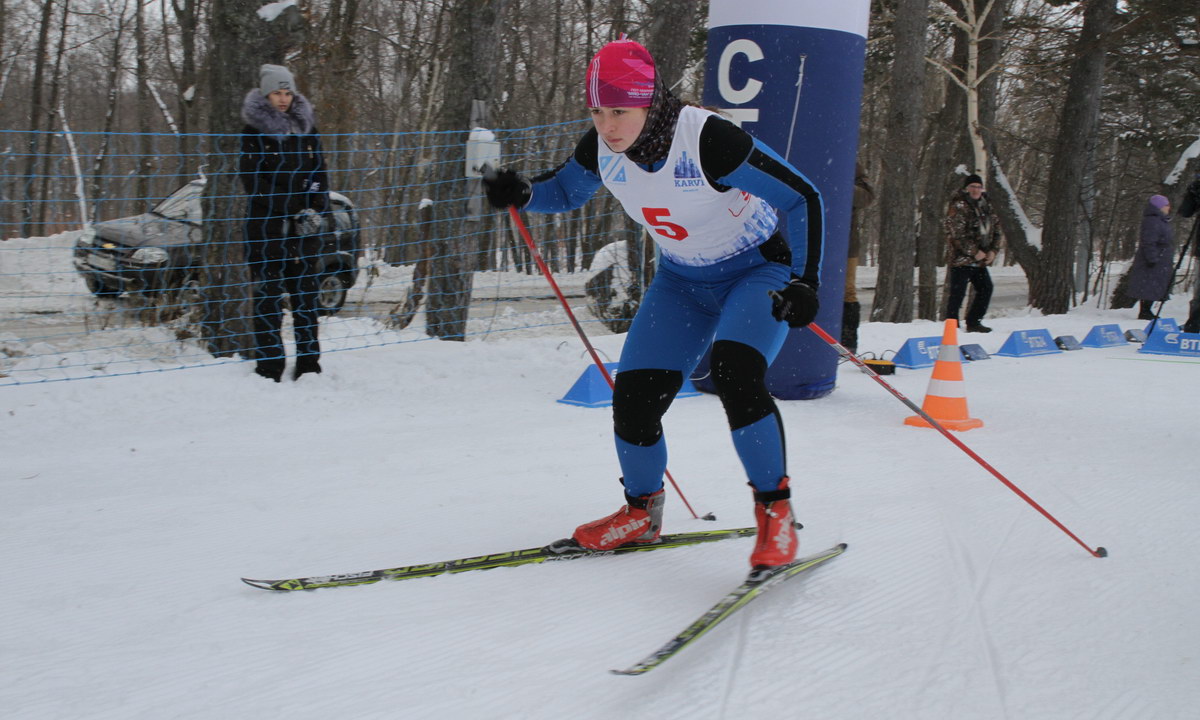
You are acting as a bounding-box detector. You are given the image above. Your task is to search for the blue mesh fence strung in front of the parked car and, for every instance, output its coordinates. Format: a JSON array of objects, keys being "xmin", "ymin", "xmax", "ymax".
[{"xmin": 0, "ymin": 121, "xmax": 648, "ymax": 385}]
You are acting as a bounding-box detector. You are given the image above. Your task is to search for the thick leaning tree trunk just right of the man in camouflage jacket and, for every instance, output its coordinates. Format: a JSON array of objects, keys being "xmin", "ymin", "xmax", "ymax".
[{"xmin": 1025, "ymin": 0, "xmax": 1117, "ymax": 314}]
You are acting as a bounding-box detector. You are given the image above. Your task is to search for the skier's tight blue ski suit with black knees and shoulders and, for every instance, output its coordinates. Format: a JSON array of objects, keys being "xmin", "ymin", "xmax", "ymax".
[{"xmin": 524, "ymin": 108, "xmax": 824, "ymax": 497}]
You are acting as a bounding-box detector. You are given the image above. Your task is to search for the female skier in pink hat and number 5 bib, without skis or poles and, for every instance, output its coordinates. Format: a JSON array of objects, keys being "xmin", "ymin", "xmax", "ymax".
[{"xmin": 485, "ymin": 38, "xmax": 824, "ymax": 568}]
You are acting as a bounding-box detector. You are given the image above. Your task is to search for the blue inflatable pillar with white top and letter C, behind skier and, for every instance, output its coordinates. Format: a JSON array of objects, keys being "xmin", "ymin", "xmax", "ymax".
[{"xmin": 695, "ymin": 0, "xmax": 871, "ymax": 400}]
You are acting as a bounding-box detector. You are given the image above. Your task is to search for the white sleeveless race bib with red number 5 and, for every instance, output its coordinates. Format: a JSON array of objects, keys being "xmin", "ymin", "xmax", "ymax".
[{"xmin": 596, "ymin": 106, "xmax": 779, "ymax": 266}]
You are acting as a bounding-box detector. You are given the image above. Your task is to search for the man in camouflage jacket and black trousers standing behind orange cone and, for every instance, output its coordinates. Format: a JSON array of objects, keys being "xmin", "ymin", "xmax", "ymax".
[{"xmin": 942, "ymin": 175, "xmax": 1001, "ymax": 332}]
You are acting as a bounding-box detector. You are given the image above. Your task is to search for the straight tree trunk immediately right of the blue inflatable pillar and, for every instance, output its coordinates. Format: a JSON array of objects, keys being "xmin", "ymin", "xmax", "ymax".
[{"xmin": 871, "ymin": 0, "xmax": 929, "ymax": 323}]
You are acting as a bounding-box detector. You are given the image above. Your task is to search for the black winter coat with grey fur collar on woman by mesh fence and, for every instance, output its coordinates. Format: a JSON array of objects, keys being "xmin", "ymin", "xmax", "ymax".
[{"xmin": 238, "ymin": 89, "xmax": 329, "ymax": 240}]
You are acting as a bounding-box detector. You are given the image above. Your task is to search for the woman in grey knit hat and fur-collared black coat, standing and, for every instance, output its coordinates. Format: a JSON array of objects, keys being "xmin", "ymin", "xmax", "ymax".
[{"xmin": 239, "ymin": 65, "xmax": 330, "ymax": 383}]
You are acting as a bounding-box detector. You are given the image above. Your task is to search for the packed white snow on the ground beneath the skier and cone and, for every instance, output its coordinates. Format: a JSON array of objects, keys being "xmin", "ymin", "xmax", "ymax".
[{"xmin": 0, "ymin": 262, "xmax": 1200, "ymax": 720}]
